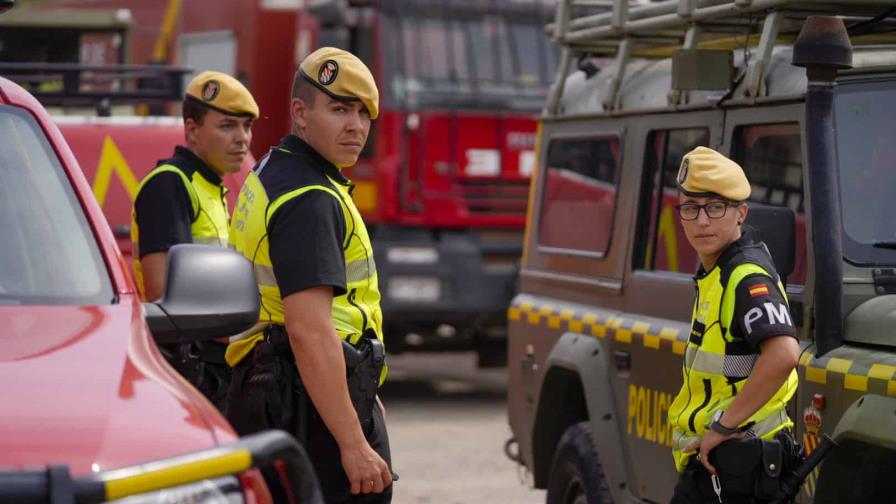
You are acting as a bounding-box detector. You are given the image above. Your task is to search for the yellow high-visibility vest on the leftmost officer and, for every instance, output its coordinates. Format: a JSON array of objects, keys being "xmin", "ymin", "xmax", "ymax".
[{"xmin": 131, "ymin": 164, "xmax": 230, "ymax": 299}]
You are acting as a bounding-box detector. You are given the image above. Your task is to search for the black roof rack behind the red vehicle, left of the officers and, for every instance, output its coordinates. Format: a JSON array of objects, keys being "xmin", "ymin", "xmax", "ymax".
[{"xmin": 0, "ymin": 62, "xmax": 192, "ymax": 115}]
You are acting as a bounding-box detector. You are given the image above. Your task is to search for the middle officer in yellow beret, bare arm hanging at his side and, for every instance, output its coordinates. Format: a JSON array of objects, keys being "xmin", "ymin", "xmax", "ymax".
[{"xmin": 227, "ymin": 47, "xmax": 392, "ymax": 503}]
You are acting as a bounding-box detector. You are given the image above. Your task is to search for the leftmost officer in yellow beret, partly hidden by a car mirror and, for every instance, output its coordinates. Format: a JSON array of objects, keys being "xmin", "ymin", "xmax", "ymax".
[{"xmin": 131, "ymin": 72, "xmax": 258, "ymax": 410}]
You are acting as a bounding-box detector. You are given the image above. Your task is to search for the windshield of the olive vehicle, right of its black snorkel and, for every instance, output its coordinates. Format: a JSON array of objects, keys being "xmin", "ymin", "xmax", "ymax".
[{"xmin": 834, "ymin": 81, "xmax": 896, "ymax": 265}]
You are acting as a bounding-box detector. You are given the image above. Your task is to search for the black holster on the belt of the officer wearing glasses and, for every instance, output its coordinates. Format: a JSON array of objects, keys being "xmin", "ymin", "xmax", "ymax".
[{"xmin": 709, "ymin": 437, "xmax": 784, "ymax": 500}]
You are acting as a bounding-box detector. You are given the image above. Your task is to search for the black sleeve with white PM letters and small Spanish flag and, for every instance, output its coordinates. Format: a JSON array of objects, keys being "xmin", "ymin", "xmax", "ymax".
[{"xmin": 731, "ymin": 273, "xmax": 796, "ymax": 351}]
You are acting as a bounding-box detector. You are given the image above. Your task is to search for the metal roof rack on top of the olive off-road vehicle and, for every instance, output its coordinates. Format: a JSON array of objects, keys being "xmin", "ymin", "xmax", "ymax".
[{"xmin": 546, "ymin": 0, "xmax": 896, "ymax": 114}]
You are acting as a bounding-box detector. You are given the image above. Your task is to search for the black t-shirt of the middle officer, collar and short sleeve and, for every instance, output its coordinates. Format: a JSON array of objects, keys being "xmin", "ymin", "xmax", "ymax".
[{"xmin": 256, "ymin": 135, "xmax": 350, "ymax": 298}]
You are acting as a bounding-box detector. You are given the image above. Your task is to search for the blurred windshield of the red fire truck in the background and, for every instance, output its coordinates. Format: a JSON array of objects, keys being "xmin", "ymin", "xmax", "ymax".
[{"xmin": 380, "ymin": 9, "xmax": 557, "ymax": 111}]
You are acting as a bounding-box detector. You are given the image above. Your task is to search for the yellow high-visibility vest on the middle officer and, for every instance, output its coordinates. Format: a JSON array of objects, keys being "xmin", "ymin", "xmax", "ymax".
[{"xmin": 226, "ymin": 161, "xmax": 385, "ymax": 376}]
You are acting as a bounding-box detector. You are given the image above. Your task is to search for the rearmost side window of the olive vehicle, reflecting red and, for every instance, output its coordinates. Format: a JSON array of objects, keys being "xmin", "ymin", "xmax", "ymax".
[{"xmin": 538, "ymin": 137, "xmax": 619, "ymax": 255}]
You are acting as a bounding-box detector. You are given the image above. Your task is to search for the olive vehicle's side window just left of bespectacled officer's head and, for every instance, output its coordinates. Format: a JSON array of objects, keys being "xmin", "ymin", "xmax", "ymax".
[{"xmin": 634, "ymin": 128, "xmax": 709, "ymax": 273}]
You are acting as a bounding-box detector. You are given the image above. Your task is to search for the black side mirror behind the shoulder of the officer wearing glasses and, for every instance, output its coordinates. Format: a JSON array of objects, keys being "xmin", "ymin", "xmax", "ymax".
[{"xmin": 744, "ymin": 203, "xmax": 796, "ymax": 279}]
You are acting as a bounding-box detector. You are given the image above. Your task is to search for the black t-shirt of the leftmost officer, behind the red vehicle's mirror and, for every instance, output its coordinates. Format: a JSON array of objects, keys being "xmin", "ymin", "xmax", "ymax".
[{"xmin": 134, "ymin": 146, "xmax": 221, "ymax": 259}]
